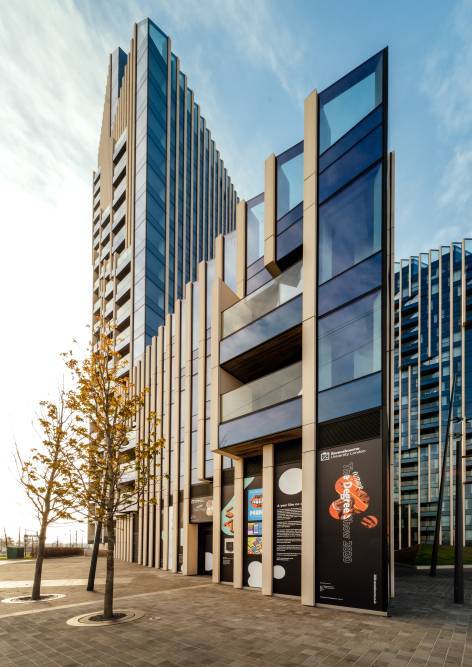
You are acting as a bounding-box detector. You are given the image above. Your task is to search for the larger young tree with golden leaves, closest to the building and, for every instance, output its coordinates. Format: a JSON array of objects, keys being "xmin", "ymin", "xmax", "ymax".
[{"xmin": 66, "ymin": 324, "xmax": 163, "ymax": 619}]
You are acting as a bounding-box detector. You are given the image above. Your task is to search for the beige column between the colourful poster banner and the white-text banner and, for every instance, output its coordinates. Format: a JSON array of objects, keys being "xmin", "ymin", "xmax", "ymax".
[{"xmin": 262, "ymin": 445, "xmax": 274, "ymax": 595}]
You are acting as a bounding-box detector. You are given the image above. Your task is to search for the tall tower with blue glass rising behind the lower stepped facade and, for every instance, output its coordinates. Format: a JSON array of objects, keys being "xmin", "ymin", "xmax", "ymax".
[{"xmin": 93, "ymin": 19, "xmax": 237, "ymax": 373}]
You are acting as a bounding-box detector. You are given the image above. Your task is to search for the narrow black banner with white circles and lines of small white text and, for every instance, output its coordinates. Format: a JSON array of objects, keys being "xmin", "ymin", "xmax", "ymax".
[{"xmin": 273, "ymin": 461, "xmax": 302, "ymax": 595}]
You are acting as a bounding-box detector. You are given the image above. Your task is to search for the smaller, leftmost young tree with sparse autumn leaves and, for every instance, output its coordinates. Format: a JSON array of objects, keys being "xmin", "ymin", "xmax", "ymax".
[{"xmin": 15, "ymin": 389, "xmax": 77, "ymax": 600}]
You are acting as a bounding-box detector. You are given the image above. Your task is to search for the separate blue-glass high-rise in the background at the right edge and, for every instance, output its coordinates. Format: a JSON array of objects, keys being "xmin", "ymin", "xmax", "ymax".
[{"xmin": 392, "ymin": 239, "xmax": 472, "ymax": 548}]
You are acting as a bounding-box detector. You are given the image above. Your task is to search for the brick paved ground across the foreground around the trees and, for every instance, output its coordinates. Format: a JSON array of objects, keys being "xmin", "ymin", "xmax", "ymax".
[{"xmin": 0, "ymin": 559, "xmax": 472, "ymax": 667}]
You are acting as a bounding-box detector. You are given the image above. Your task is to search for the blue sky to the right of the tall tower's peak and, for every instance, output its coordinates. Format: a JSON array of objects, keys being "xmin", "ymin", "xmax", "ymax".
[{"xmin": 77, "ymin": 0, "xmax": 472, "ymax": 256}]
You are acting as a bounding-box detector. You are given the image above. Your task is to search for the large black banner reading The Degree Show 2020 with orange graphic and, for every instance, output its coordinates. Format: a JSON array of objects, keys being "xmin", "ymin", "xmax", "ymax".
[{"xmin": 316, "ymin": 439, "xmax": 386, "ymax": 611}]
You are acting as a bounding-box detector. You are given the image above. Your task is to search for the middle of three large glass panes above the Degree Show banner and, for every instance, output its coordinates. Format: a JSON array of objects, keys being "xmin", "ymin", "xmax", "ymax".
[{"xmin": 319, "ymin": 165, "xmax": 382, "ymax": 284}]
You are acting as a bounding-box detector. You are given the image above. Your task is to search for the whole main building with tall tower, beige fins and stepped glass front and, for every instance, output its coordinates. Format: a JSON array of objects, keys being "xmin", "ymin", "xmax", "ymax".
[{"xmin": 94, "ymin": 21, "xmax": 394, "ymax": 612}]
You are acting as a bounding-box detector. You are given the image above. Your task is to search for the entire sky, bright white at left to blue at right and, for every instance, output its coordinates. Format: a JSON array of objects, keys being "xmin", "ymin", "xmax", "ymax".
[{"xmin": 0, "ymin": 0, "xmax": 472, "ymax": 540}]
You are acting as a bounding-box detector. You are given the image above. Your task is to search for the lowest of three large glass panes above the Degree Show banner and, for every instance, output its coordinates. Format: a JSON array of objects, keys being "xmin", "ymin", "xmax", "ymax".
[{"xmin": 318, "ymin": 291, "xmax": 382, "ymax": 391}]
